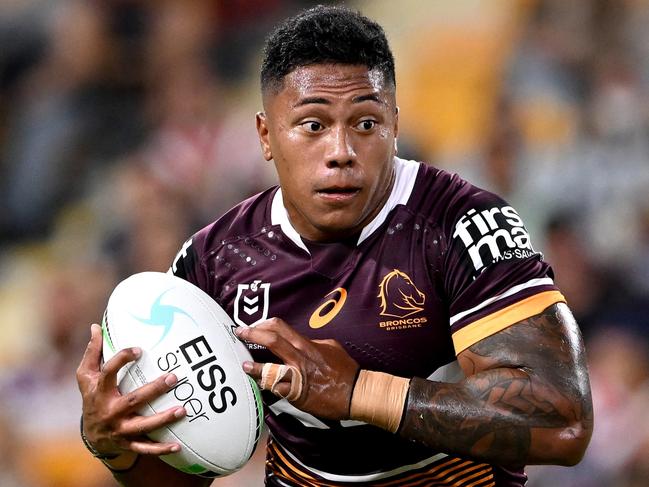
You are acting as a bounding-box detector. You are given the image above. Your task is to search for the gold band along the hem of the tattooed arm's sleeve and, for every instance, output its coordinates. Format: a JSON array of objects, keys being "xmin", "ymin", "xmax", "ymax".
[{"xmin": 453, "ymin": 291, "xmax": 566, "ymax": 354}]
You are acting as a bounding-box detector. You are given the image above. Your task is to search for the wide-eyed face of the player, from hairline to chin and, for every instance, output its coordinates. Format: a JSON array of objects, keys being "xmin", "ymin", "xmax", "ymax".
[{"xmin": 257, "ymin": 64, "xmax": 398, "ymax": 241}]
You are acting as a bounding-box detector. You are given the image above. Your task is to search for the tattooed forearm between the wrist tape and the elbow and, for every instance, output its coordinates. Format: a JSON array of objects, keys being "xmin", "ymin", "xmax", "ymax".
[{"xmin": 399, "ymin": 369, "xmax": 588, "ymax": 466}]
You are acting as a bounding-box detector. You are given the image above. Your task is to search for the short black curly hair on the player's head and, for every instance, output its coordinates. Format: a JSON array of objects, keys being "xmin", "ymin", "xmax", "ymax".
[{"xmin": 261, "ymin": 5, "xmax": 396, "ymax": 92}]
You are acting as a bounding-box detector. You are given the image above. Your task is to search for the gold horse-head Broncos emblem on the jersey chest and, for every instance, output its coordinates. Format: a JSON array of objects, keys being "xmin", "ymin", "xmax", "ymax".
[{"xmin": 378, "ymin": 269, "xmax": 426, "ymax": 318}]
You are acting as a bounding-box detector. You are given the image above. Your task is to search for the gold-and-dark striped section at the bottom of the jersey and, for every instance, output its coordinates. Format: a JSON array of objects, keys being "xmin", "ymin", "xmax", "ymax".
[{"xmin": 266, "ymin": 439, "xmax": 495, "ymax": 487}]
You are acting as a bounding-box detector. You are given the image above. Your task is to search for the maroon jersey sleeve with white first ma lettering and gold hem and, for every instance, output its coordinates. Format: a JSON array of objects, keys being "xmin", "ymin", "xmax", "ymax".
[{"xmin": 444, "ymin": 185, "xmax": 565, "ymax": 354}]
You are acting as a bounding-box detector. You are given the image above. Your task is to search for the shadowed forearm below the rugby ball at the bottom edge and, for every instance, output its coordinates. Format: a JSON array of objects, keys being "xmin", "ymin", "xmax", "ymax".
[{"xmin": 111, "ymin": 455, "xmax": 212, "ymax": 487}]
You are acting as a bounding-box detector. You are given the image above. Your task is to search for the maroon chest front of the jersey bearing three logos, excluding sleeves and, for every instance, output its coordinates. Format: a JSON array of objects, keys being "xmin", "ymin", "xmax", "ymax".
[{"xmin": 207, "ymin": 217, "xmax": 454, "ymax": 377}]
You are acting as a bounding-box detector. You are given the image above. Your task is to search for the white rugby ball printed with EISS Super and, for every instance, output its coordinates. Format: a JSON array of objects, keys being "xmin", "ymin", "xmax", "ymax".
[{"xmin": 102, "ymin": 272, "xmax": 263, "ymax": 475}]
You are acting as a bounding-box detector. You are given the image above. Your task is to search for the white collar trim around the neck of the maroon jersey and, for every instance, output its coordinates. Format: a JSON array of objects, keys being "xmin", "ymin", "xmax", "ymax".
[{"xmin": 270, "ymin": 157, "xmax": 420, "ymax": 252}]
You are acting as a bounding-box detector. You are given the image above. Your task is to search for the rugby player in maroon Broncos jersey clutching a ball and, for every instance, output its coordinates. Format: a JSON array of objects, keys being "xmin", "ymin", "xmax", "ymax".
[{"xmin": 78, "ymin": 6, "xmax": 593, "ymax": 487}]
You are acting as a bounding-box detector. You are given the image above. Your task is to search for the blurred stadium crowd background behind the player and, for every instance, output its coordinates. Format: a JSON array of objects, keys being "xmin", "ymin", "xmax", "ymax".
[{"xmin": 0, "ymin": 0, "xmax": 649, "ymax": 487}]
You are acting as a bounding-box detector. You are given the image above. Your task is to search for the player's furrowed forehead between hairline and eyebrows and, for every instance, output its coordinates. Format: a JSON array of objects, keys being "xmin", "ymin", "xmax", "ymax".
[{"xmin": 264, "ymin": 64, "xmax": 394, "ymax": 107}]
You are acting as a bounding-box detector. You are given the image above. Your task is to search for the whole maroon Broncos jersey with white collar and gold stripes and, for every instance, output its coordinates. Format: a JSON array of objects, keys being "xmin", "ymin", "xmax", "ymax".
[{"xmin": 172, "ymin": 158, "xmax": 563, "ymax": 487}]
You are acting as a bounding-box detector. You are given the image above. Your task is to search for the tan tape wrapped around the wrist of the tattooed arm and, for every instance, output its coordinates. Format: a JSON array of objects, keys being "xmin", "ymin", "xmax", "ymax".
[{"xmin": 349, "ymin": 370, "xmax": 410, "ymax": 433}]
